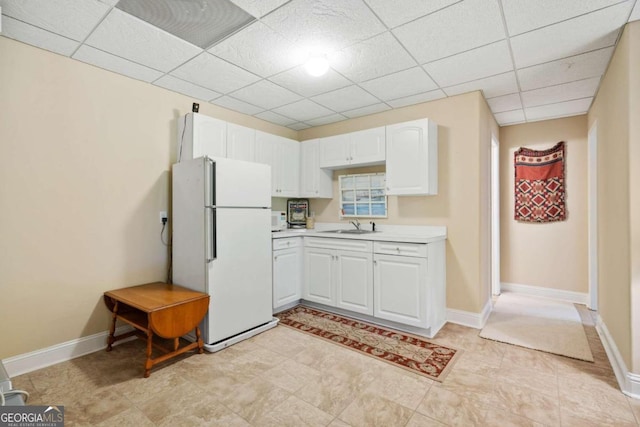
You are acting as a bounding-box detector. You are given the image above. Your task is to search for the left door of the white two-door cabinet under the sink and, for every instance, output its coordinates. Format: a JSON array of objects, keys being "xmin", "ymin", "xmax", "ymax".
[{"xmin": 302, "ymin": 248, "xmax": 336, "ymax": 305}]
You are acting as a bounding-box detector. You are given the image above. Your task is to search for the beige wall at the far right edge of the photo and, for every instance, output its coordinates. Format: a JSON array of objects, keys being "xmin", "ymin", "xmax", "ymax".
[{"xmin": 589, "ymin": 22, "xmax": 640, "ymax": 372}]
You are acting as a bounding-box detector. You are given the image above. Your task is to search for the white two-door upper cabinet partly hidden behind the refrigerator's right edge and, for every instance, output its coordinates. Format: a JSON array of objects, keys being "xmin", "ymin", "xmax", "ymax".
[{"xmin": 255, "ymin": 131, "xmax": 300, "ymax": 197}]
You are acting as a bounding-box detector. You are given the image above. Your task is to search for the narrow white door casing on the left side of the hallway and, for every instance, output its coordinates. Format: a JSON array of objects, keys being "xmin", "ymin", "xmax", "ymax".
[{"xmin": 491, "ymin": 135, "xmax": 500, "ymax": 296}]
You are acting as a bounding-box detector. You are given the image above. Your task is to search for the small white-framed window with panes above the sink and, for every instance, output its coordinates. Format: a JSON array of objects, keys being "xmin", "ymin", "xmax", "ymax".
[{"xmin": 339, "ymin": 173, "xmax": 387, "ymax": 218}]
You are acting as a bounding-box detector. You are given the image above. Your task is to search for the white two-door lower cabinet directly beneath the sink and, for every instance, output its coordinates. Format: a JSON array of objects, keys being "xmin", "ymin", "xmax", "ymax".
[{"xmin": 302, "ymin": 237, "xmax": 373, "ymax": 315}]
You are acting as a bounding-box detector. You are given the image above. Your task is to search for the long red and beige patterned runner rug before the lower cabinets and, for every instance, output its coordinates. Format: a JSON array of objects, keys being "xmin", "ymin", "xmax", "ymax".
[{"xmin": 276, "ymin": 305, "xmax": 461, "ymax": 381}]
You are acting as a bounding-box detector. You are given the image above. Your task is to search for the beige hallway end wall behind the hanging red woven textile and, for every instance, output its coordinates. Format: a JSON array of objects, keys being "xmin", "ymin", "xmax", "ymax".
[{"xmin": 500, "ymin": 116, "xmax": 589, "ymax": 293}]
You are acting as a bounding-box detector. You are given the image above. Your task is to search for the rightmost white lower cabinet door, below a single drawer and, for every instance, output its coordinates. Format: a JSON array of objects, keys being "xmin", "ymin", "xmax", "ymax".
[{"xmin": 373, "ymin": 254, "xmax": 430, "ymax": 328}]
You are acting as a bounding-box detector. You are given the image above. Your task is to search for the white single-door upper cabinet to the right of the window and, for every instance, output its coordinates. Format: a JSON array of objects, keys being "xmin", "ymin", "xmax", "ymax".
[{"xmin": 386, "ymin": 119, "xmax": 438, "ymax": 196}]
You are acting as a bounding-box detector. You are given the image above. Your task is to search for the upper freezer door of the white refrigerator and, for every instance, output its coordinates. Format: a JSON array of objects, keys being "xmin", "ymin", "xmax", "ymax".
[{"xmin": 212, "ymin": 157, "xmax": 271, "ymax": 208}]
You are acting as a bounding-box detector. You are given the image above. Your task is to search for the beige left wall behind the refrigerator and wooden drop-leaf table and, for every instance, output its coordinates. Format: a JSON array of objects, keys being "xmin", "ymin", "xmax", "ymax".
[{"xmin": 0, "ymin": 37, "xmax": 297, "ymax": 358}]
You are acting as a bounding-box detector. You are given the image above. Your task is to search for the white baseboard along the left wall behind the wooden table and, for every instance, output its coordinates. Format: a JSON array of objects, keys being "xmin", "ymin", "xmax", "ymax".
[{"xmin": 2, "ymin": 325, "xmax": 135, "ymax": 378}]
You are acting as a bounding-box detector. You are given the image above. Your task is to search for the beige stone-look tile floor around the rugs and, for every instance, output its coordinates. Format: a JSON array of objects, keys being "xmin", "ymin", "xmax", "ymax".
[{"xmin": 14, "ymin": 308, "xmax": 640, "ymax": 427}]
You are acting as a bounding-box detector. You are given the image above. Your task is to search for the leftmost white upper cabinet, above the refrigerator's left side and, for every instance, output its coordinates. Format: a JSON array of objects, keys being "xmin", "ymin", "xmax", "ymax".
[{"xmin": 176, "ymin": 113, "xmax": 227, "ymax": 162}]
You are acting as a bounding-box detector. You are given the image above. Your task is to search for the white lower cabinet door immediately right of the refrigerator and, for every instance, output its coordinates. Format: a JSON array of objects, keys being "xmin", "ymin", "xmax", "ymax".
[{"xmin": 273, "ymin": 248, "xmax": 302, "ymax": 308}]
